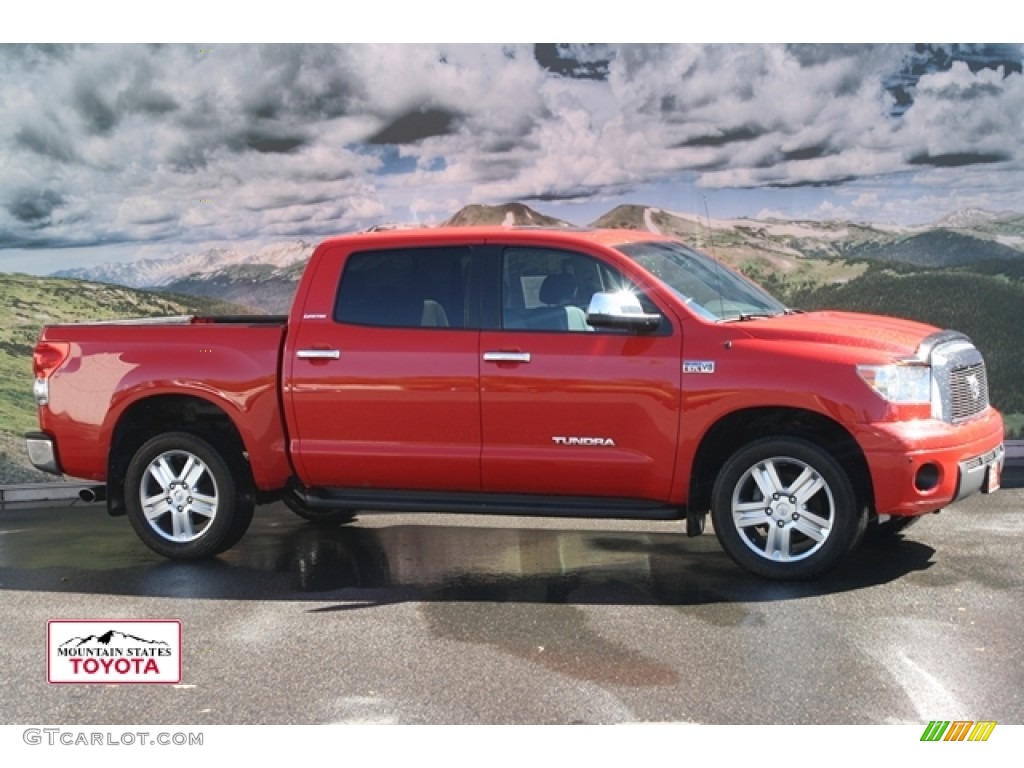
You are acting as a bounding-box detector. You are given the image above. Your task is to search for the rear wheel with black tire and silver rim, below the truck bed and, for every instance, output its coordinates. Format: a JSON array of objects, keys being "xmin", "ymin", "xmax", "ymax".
[{"xmin": 125, "ymin": 432, "xmax": 253, "ymax": 560}]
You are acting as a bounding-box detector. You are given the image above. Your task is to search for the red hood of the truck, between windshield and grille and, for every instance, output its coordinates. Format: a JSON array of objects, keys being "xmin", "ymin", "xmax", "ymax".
[{"xmin": 735, "ymin": 311, "xmax": 939, "ymax": 357}]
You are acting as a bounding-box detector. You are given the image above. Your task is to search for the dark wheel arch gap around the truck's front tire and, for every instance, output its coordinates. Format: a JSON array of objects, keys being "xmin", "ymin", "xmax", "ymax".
[{"xmin": 687, "ymin": 407, "xmax": 874, "ymax": 512}]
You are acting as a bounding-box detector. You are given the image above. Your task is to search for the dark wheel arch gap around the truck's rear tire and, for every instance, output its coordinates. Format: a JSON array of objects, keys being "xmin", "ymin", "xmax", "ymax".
[{"xmin": 106, "ymin": 394, "xmax": 256, "ymax": 516}]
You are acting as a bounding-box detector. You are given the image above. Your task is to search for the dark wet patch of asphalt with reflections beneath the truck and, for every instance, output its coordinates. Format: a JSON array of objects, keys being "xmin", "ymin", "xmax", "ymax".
[{"xmin": 0, "ymin": 505, "xmax": 934, "ymax": 611}]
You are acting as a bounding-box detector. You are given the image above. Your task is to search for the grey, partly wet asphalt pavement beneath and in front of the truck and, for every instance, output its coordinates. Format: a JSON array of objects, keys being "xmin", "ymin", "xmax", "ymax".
[{"xmin": 0, "ymin": 466, "xmax": 1024, "ymax": 725}]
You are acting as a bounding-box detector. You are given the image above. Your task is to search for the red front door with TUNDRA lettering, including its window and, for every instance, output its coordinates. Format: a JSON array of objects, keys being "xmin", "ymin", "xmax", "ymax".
[{"xmin": 480, "ymin": 246, "xmax": 682, "ymax": 501}]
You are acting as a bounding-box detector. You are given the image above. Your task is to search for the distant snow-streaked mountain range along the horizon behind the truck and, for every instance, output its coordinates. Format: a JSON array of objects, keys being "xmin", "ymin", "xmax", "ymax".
[{"xmin": 44, "ymin": 203, "xmax": 1024, "ymax": 313}]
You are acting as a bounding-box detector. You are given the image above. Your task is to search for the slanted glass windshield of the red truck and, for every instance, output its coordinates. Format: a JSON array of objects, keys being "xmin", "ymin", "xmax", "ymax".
[{"xmin": 618, "ymin": 242, "xmax": 786, "ymax": 321}]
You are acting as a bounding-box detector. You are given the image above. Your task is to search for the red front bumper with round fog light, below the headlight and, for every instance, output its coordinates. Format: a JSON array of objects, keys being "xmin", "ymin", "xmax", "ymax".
[{"xmin": 855, "ymin": 409, "xmax": 1006, "ymax": 515}]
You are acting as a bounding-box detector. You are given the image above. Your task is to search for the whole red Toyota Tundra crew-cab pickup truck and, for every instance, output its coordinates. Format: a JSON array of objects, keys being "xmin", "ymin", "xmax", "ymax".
[{"xmin": 27, "ymin": 227, "xmax": 1004, "ymax": 579}]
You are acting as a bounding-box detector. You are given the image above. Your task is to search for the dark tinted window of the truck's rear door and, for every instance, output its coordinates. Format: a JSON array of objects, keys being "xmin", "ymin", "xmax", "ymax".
[{"xmin": 334, "ymin": 247, "xmax": 470, "ymax": 329}]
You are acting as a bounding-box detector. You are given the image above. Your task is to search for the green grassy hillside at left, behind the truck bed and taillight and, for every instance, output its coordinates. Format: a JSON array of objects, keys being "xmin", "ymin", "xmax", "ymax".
[{"xmin": 0, "ymin": 273, "xmax": 252, "ymax": 483}]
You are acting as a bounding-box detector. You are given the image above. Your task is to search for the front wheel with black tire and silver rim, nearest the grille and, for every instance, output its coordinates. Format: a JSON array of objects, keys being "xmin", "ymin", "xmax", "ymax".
[{"xmin": 712, "ymin": 437, "xmax": 866, "ymax": 580}]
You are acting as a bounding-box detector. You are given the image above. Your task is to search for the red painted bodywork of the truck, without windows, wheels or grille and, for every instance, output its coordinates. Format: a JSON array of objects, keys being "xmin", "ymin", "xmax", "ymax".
[{"xmin": 34, "ymin": 227, "xmax": 1002, "ymax": 515}]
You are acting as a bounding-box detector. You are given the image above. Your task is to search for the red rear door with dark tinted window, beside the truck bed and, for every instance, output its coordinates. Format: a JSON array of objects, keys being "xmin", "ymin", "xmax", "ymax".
[{"xmin": 286, "ymin": 241, "xmax": 480, "ymax": 492}]
